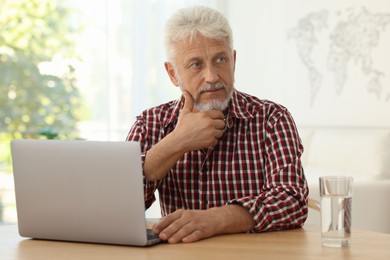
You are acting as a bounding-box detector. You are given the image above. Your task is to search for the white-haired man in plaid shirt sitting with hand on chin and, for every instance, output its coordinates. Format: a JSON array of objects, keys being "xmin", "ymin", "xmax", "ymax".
[{"xmin": 127, "ymin": 6, "xmax": 308, "ymax": 243}]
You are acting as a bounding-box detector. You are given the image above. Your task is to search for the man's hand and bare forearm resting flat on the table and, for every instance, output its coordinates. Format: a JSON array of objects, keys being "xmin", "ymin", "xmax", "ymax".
[{"xmin": 153, "ymin": 205, "xmax": 254, "ymax": 243}]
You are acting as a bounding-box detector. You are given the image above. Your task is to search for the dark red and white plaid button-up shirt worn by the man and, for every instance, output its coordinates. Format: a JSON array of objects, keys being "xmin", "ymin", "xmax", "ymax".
[{"xmin": 127, "ymin": 90, "xmax": 308, "ymax": 232}]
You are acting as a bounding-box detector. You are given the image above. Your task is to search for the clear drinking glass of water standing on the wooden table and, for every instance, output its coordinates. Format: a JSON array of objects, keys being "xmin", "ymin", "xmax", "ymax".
[{"xmin": 320, "ymin": 176, "xmax": 353, "ymax": 247}]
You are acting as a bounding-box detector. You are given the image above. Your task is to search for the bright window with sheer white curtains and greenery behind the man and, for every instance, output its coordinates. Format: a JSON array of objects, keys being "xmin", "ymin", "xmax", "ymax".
[{"xmin": 0, "ymin": 0, "xmax": 226, "ymax": 222}]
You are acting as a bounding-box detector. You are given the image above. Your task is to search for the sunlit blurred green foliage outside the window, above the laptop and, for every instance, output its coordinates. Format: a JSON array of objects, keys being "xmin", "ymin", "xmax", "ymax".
[{"xmin": 0, "ymin": 0, "xmax": 83, "ymax": 172}]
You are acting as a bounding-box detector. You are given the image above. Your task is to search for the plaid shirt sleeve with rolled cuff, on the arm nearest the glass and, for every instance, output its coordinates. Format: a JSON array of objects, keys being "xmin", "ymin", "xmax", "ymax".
[{"xmin": 229, "ymin": 109, "xmax": 308, "ymax": 232}]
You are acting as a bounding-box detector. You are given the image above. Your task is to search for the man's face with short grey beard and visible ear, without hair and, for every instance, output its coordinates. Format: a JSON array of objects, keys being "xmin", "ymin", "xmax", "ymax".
[{"xmin": 165, "ymin": 35, "xmax": 236, "ymax": 111}]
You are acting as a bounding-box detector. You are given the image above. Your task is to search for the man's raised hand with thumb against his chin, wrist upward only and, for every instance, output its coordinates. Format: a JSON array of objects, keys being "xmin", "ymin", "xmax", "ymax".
[{"xmin": 172, "ymin": 91, "xmax": 225, "ymax": 152}]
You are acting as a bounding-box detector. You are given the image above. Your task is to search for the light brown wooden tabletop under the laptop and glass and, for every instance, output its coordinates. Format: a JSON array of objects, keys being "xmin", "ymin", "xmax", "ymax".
[{"xmin": 0, "ymin": 225, "xmax": 390, "ymax": 260}]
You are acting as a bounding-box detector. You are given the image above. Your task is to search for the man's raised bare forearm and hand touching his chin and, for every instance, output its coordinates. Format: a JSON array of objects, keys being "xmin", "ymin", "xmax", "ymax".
[{"xmin": 144, "ymin": 91, "xmax": 225, "ymax": 181}]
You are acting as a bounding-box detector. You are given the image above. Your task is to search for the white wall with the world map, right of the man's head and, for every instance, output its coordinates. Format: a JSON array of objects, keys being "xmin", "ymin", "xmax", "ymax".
[{"xmin": 227, "ymin": 0, "xmax": 390, "ymax": 127}]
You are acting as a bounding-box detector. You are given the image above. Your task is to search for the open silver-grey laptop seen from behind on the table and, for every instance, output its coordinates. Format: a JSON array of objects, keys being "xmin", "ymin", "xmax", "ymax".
[{"xmin": 11, "ymin": 140, "xmax": 160, "ymax": 246}]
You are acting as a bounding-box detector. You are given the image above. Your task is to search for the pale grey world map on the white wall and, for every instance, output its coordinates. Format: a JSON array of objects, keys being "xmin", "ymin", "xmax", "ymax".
[{"xmin": 287, "ymin": 7, "xmax": 390, "ymax": 105}]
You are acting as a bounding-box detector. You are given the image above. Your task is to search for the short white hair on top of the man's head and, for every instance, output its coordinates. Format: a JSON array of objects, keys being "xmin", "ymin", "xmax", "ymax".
[{"xmin": 164, "ymin": 6, "xmax": 233, "ymax": 62}]
